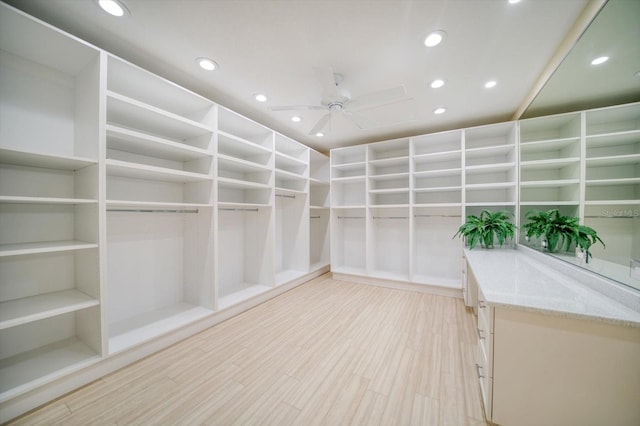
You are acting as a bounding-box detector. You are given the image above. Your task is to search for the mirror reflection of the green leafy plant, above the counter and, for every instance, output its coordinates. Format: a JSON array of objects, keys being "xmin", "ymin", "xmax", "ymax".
[{"xmin": 522, "ymin": 209, "xmax": 606, "ymax": 261}]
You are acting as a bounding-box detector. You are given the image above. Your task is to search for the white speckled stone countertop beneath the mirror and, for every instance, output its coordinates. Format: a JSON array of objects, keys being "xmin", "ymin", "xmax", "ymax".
[{"xmin": 465, "ymin": 249, "xmax": 640, "ymax": 327}]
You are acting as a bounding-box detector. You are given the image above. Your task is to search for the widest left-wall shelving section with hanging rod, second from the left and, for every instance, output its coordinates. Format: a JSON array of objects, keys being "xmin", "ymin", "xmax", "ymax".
[{"xmin": 105, "ymin": 56, "xmax": 215, "ymax": 353}]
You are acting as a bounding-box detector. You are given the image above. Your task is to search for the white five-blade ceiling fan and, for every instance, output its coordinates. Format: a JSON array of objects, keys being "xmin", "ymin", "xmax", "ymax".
[{"xmin": 270, "ymin": 67, "xmax": 406, "ymax": 135}]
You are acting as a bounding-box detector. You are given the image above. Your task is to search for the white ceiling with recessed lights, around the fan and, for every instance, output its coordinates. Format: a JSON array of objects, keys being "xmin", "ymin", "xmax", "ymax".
[{"xmin": 1, "ymin": 0, "xmax": 608, "ymax": 151}]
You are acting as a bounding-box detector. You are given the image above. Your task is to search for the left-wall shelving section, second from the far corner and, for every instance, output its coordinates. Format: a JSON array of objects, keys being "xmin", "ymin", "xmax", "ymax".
[{"xmin": 274, "ymin": 133, "xmax": 310, "ymax": 285}]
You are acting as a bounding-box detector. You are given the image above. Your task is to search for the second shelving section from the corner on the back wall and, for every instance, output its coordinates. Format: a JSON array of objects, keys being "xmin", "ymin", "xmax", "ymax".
[{"xmin": 366, "ymin": 139, "xmax": 410, "ymax": 281}]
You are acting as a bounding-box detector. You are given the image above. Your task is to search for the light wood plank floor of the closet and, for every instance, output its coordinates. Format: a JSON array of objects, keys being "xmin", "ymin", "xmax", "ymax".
[{"xmin": 14, "ymin": 274, "xmax": 485, "ymax": 426}]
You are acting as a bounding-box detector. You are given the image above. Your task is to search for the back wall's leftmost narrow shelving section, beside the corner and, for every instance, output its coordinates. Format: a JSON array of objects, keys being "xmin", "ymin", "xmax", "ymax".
[{"xmin": 330, "ymin": 146, "xmax": 367, "ymax": 275}]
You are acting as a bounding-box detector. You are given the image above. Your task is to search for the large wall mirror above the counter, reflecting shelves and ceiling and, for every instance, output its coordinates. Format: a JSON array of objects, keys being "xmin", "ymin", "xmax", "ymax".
[{"xmin": 520, "ymin": 0, "xmax": 640, "ymax": 290}]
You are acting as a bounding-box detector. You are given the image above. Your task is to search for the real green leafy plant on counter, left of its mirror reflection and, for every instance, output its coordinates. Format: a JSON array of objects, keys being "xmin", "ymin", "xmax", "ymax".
[{"xmin": 453, "ymin": 210, "xmax": 516, "ymax": 249}]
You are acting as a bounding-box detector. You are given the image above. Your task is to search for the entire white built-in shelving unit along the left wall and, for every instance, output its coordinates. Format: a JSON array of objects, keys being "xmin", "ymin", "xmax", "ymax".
[{"xmin": 0, "ymin": 4, "xmax": 329, "ymax": 422}]
